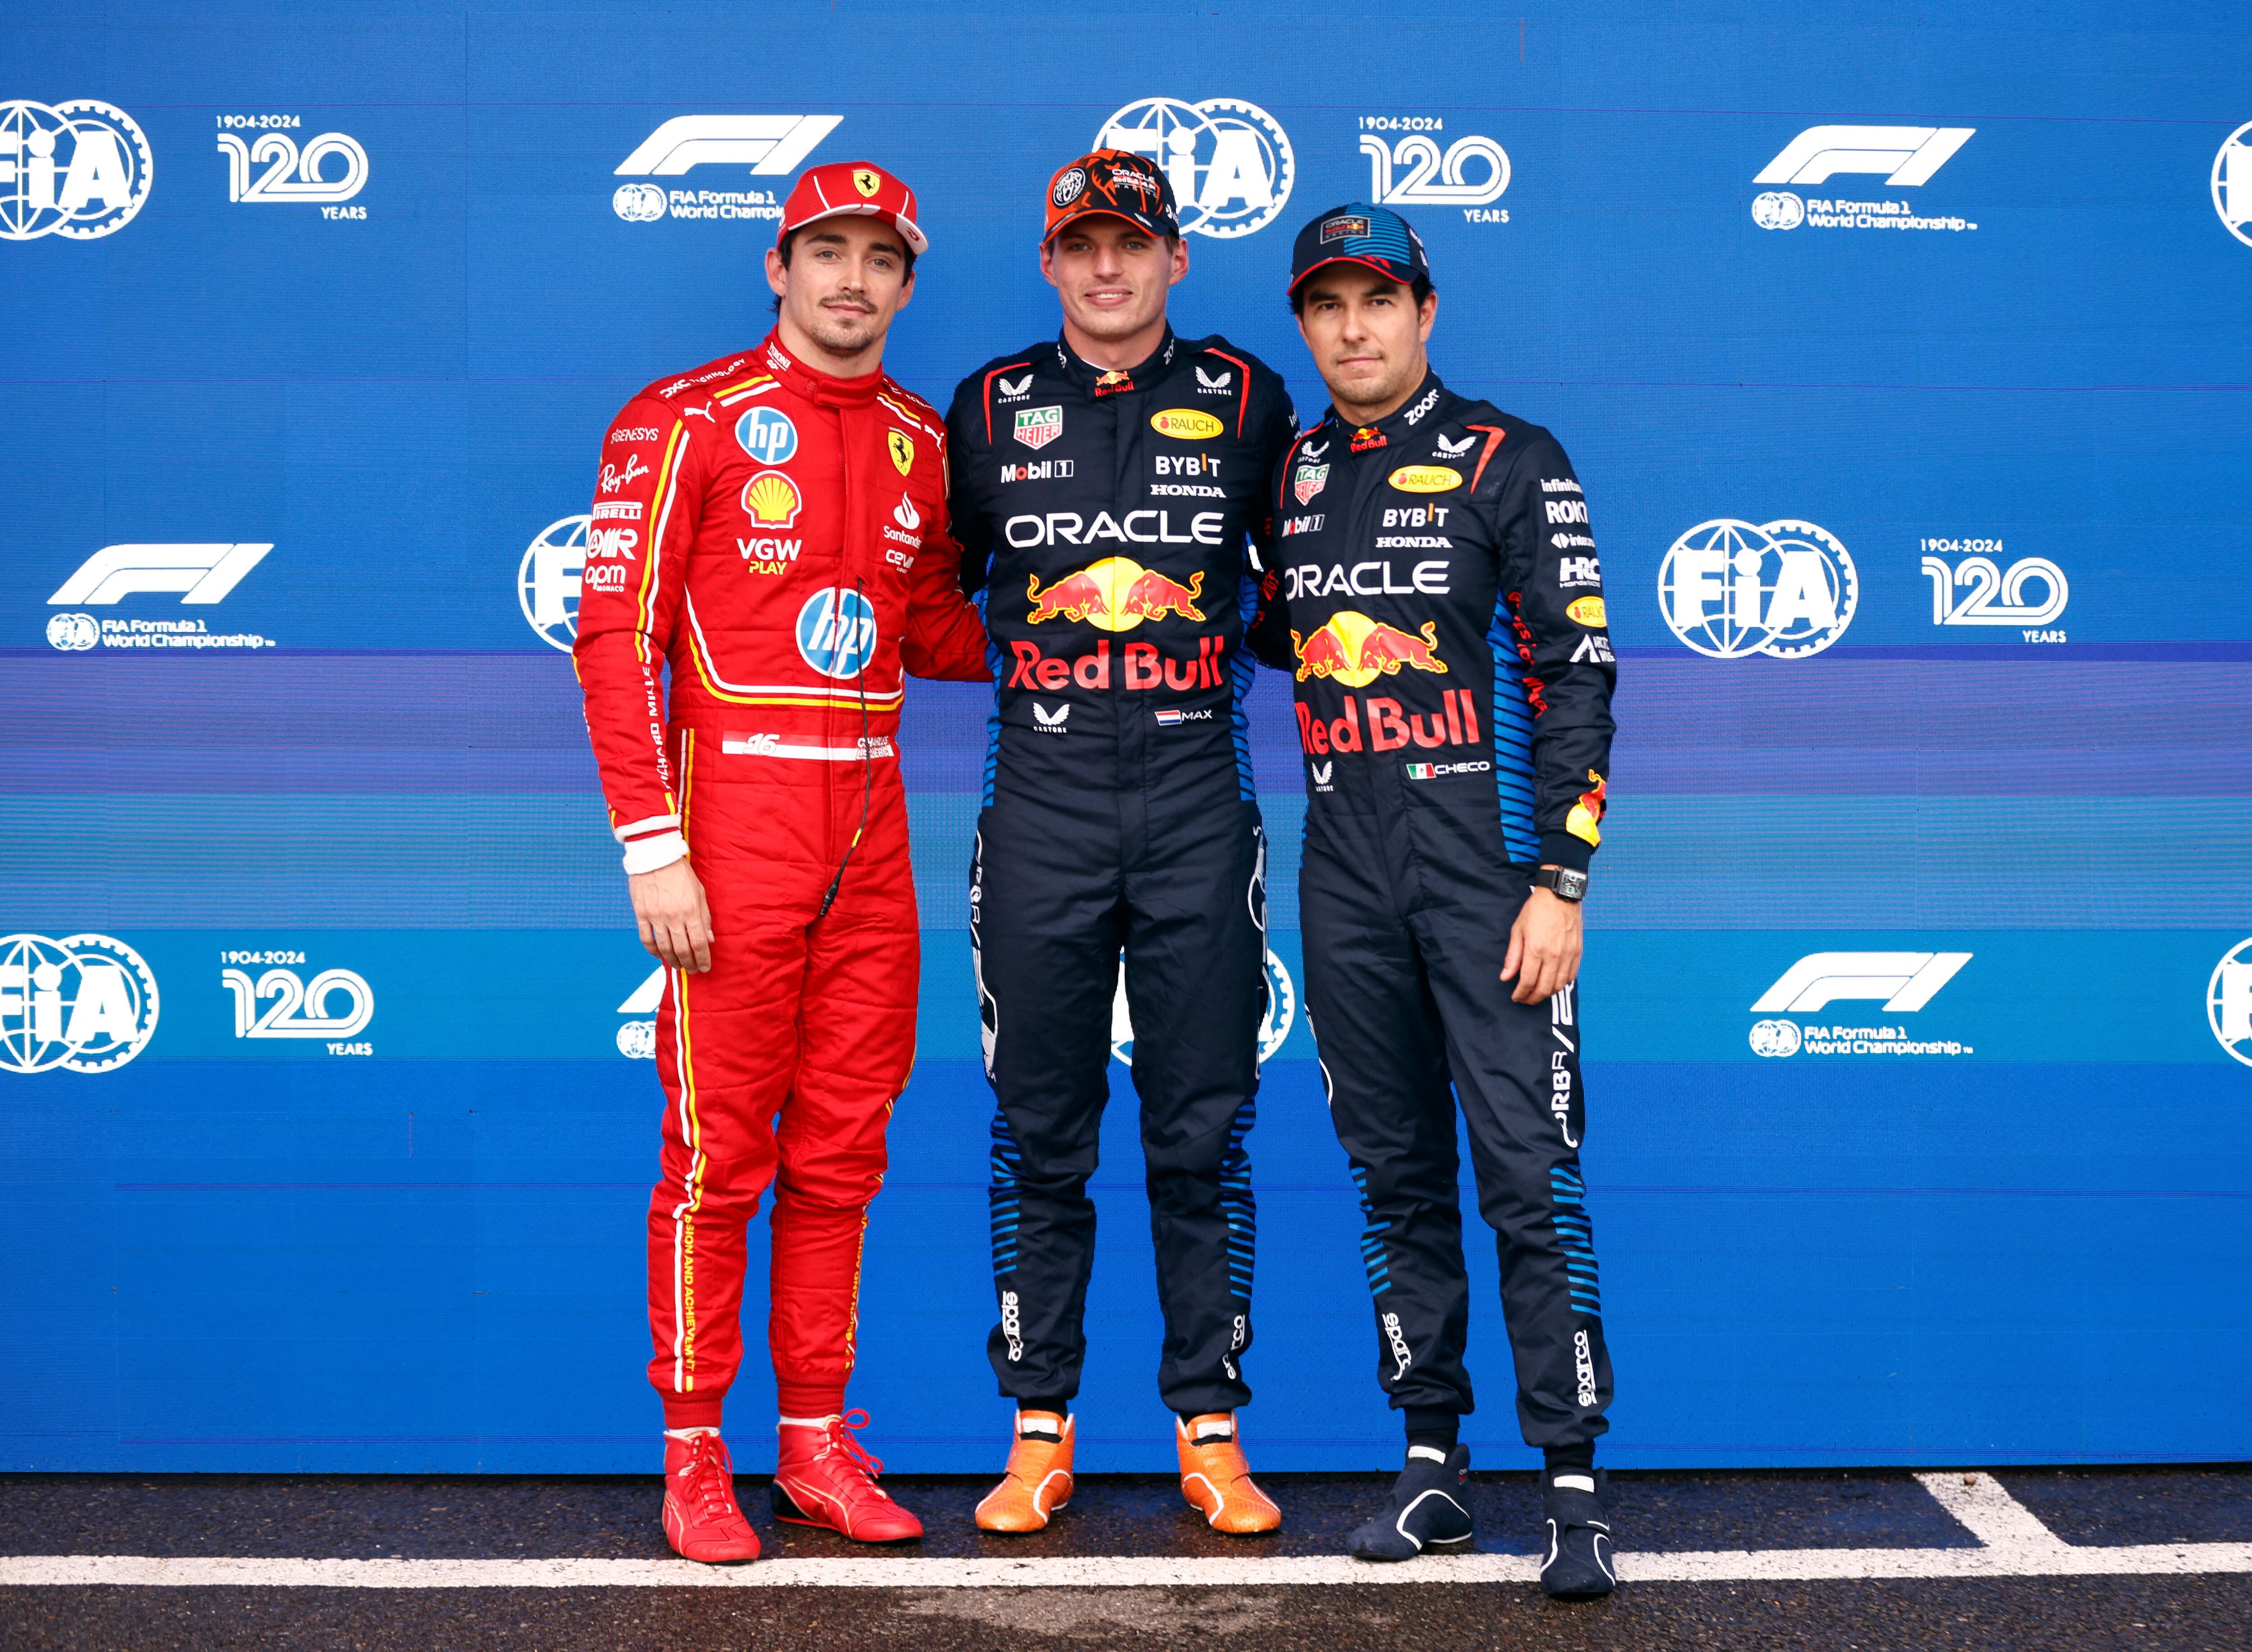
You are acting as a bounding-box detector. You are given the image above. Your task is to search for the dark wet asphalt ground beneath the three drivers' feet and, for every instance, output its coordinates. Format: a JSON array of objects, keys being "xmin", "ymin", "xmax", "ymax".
[{"xmin": 0, "ymin": 1467, "xmax": 2252, "ymax": 1652}]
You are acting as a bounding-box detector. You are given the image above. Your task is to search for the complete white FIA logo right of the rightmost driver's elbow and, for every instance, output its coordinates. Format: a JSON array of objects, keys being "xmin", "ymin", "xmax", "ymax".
[{"xmin": 1657, "ymin": 515, "xmax": 1860, "ymax": 659}]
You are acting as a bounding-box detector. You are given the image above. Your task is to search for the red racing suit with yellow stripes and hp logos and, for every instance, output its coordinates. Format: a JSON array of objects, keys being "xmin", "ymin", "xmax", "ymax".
[{"xmin": 574, "ymin": 336, "xmax": 991, "ymax": 1427}]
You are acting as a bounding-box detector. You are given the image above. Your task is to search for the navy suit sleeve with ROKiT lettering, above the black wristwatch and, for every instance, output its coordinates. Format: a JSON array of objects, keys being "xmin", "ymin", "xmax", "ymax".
[{"xmin": 1491, "ymin": 427, "xmax": 1619, "ymax": 871}]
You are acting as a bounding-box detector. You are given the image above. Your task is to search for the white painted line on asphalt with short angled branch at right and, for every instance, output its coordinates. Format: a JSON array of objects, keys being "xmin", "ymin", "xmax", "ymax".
[{"xmin": 0, "ymin": 1472, "xmax": 2252, "ymax": 1589}]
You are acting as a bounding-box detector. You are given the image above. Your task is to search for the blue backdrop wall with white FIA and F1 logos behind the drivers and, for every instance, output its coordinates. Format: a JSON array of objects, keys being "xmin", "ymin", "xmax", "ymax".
[{"xmin": 0, "ymin": 0, "xmax": 2252, "ymax": 1470}]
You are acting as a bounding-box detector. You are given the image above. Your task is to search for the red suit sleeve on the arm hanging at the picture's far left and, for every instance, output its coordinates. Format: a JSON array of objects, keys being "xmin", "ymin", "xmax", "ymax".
[{"xmin": 572, "ymin": 396, "xmax": 703, "ymax": 871}]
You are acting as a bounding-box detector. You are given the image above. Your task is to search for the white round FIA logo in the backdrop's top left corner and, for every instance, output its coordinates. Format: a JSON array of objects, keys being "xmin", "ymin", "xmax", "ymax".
[{"xmin": 0, "ymin": 97, "xmax": 153, "ymax": 241}]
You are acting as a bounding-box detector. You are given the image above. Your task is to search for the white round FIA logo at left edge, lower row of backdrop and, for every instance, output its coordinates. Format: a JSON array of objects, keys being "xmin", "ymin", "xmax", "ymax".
[{"xmin": 0, "ymin": 934, "xmax": 158, "ymax": 1074}]
